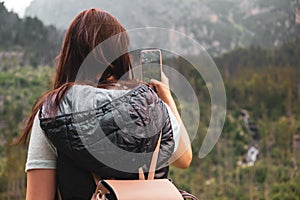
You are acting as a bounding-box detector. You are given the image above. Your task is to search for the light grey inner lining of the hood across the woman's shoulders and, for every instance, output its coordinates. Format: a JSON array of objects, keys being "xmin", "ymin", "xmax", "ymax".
[{"xmin": 42, "ymin": 84, "xmax": 158, "ymax": 118}]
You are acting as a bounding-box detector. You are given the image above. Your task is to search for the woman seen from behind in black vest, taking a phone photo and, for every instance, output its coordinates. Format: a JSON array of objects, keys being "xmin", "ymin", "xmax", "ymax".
[{"xmin": 19, "ymin": 9, "xmax": 192, "ymax": 200}]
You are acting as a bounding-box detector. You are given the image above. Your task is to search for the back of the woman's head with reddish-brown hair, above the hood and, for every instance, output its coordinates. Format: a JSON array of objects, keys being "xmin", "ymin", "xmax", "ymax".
[{"xmin": 53, "ymin": 8, "xmax": 131, "ymax": 89}]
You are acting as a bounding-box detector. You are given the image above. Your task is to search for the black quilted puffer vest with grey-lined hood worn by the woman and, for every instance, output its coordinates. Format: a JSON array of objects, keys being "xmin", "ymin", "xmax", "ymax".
[{"xmin": 39, "ymin": 85, "xmax": 174, "ymax": 200}]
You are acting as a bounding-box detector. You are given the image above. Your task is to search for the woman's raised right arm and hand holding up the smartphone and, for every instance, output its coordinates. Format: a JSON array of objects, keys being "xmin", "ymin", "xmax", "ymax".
[{"xmin": 150, "ymin": 74, "xmax": 192, "ymax": 168}]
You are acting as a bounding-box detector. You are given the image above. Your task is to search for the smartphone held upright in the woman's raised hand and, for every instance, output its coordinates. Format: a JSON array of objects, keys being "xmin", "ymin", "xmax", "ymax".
[{"xmin": 140, "ymin": 49, "xmax": 162, "ymax": 83}]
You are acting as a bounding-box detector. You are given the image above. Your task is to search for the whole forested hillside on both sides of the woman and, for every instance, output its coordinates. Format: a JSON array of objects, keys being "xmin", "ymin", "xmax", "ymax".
[{"xmin": 0, "ymin": 1, "xmax": 300, "ymax": 200}]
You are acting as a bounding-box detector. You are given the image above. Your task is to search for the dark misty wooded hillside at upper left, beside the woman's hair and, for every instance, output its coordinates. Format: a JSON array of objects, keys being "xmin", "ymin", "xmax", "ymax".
[{"xmin": 0, "ymin": 2, "xmax": 62, "ymax": 66}]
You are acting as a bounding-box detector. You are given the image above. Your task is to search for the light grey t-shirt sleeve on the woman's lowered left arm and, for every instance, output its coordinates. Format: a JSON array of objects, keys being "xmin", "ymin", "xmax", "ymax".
[{"xmin": 25, "ymin": 115, "xmax": 56, "ymax": 171}]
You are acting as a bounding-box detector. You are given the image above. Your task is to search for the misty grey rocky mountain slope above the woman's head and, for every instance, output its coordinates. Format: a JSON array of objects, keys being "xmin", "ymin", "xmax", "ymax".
[{"xmin": 25, "ymin": 0, "xmax": 300, "ymax": 55}]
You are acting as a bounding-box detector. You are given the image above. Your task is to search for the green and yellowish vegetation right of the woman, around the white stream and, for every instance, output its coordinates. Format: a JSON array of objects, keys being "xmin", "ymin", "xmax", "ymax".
[{"xmin": 170, "ymin": 67, "xmax": 300, "ymax": 199}]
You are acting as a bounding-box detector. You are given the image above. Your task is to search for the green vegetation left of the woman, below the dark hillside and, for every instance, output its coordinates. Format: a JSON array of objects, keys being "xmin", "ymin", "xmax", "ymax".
[{"xmin": 0, "ymin": 66, "xmax": 53, "ymax": 199}]
